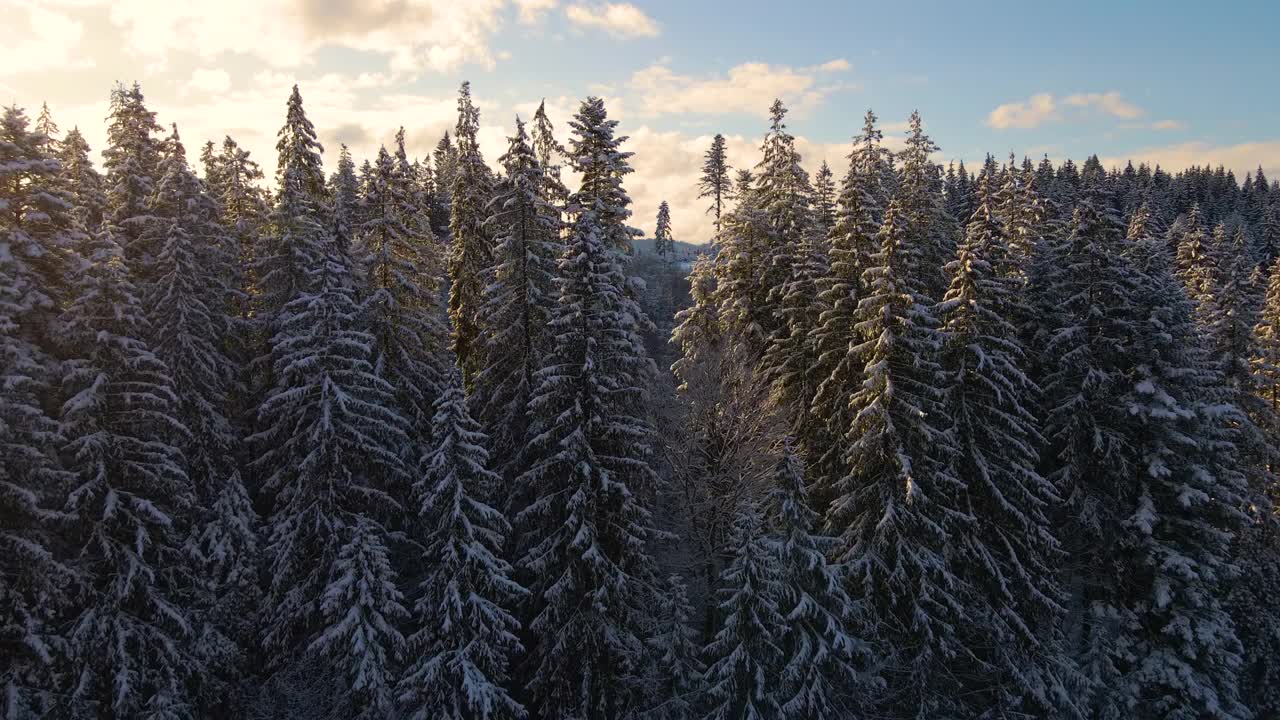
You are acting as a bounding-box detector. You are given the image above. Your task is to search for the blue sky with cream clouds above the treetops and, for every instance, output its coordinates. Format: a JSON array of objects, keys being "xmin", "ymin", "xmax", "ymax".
[{"xmin": 0, "ymin": 0, "xmax": 1280, "ymax": 241}]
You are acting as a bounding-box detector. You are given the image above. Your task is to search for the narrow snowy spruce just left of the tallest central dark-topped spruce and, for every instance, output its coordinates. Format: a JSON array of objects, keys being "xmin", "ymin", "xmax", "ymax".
[{"xmin": 470, "ymin": 118, "xmax": 561, "ymax": 476}]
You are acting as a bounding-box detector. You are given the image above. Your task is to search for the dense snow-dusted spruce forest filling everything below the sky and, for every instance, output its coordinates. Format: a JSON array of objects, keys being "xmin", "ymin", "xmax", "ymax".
[{"xmin": 0, "ymin": 78, "xmax": 1280, "ymax": 720}]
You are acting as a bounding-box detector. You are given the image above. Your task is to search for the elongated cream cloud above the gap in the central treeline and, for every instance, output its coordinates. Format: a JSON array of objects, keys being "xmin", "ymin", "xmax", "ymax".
[{"xmin": 627, "ymin": 63, "xmax": 841, "ymax": 115}]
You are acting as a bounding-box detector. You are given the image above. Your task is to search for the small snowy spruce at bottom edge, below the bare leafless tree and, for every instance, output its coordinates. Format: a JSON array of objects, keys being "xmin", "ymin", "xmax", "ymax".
[{"xmin": 703, "ymin": 505, "xmax": 787, "ymax": 720}]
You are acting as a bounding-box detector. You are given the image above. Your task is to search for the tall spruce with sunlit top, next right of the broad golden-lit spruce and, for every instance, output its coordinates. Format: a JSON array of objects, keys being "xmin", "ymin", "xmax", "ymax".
[{"xmin": 937, "ymin": 173, "xmax": 1074, "ymax": 717}]
